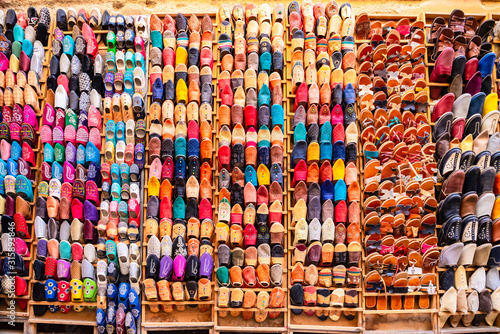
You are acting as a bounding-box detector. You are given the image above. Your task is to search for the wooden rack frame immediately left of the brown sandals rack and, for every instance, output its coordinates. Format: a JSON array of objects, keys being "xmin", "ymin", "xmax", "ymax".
[{"xmin": 285, "ymin": 16, "xmax": 363, "ymax": 333}]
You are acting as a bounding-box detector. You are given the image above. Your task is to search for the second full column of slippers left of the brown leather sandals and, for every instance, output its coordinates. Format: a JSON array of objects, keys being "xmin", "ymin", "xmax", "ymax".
[{"xmin": 215, "ymin": 4, "xmax": 286, "ymax": 323}]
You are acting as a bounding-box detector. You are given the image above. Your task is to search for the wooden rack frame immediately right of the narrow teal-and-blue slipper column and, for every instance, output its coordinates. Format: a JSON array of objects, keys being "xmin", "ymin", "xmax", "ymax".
[{"xmin": 141, "ymin": 13, "xmax": 217, "ymax": 334}]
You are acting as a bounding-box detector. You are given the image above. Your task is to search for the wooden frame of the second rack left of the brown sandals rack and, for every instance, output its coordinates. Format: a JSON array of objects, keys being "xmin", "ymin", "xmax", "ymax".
[{"xmin": 214, "ymin": 14, "xmax": 290, "ymax": 334}]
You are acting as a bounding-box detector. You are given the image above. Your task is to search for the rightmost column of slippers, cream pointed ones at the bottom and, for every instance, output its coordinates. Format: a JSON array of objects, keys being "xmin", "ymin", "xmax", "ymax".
[{"xmin": 430, "ymin": 10, "xmax": 500, "ymax": 327}]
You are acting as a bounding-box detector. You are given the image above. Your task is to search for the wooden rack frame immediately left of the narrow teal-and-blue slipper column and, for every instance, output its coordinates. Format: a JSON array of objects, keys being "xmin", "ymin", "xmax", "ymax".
[{"xmin": 28, "ymin": 17, "xmax": 115, "ymax": 334}]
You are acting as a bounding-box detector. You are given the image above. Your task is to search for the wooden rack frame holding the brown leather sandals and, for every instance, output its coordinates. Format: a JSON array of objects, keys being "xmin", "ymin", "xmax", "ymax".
[{"xmin": 355, "ymin": 14, "xmax": 439, "ymax": 333}]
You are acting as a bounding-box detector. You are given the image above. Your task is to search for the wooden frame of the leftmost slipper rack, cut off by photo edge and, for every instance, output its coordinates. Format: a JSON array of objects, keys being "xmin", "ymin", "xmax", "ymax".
[{"xmin": 0, "ymin": 13, "xmax": 55, "ymax": 326}]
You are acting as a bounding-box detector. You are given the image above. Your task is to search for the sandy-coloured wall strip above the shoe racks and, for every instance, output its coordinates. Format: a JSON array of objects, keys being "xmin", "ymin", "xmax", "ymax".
[{"xmin": 0, "ymin": 0, "xmax": 500, "ymax": 15}]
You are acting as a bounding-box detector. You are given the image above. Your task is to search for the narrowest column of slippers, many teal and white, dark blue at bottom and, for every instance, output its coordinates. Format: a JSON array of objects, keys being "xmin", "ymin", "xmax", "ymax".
[{"xmin": 96, "ymin": 10, "xmax": 149, "ymax": 333}]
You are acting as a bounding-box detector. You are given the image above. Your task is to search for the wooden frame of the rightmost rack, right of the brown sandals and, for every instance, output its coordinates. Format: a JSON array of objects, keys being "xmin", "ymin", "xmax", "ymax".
[{"xmin": 422, "ymin": 13, "xmax": 500, "ymax": 333}]
